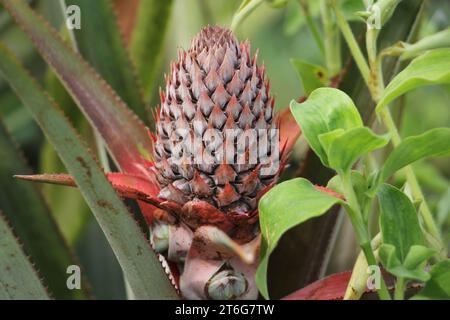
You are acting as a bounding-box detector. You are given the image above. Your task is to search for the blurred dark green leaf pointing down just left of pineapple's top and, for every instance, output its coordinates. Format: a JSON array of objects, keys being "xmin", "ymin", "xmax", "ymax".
[{"xmin": 130, "ymin": 0, "xmax": 173, "ymax": 101}]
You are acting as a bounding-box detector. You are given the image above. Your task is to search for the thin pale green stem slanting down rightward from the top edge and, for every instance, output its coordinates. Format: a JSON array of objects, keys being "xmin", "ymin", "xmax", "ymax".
[{"xmin": 332, "ymin": 0, "xmax": 370, "ymax": 86}]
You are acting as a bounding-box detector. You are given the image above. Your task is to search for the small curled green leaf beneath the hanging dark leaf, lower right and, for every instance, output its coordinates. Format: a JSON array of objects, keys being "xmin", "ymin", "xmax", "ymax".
[{"xmin": 378, "ymin": 244, "xmax": 430, "ymax": 281}]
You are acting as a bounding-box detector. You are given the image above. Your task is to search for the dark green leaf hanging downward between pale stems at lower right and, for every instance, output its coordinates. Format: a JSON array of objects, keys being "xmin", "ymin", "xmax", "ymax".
[{"xmin": 378, "ymin": 184, "xmax": 424, "ymax": 262}]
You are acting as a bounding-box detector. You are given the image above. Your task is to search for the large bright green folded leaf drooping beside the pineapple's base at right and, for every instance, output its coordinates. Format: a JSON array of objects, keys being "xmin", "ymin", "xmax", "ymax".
[{"xmin": 256, "ymin": 178, "xmax": 341, "ymax": 298}]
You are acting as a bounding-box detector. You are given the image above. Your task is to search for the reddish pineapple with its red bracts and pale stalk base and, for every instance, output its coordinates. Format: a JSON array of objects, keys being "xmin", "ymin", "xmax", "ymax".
[{"xmin": 29, "ymin": 26, "xmax": 292, "ymax": 299}]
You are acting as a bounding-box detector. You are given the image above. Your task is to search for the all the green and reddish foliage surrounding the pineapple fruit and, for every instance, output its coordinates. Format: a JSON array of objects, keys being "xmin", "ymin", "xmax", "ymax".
[{"xmin": 0, "ymin": 0, "xmax": 450, "ymax": 299}]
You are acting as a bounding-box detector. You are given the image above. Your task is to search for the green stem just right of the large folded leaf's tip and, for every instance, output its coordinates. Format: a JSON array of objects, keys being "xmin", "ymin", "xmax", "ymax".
[{"xmin": 339, "ymin": 171, "xmax": 391, "ymax": 300}]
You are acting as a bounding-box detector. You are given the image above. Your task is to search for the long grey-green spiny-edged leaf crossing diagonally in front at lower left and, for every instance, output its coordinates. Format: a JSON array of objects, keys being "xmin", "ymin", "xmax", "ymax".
[{"xmin": 0, "ymin": 43, "xmax": 177, "ymax": 299}]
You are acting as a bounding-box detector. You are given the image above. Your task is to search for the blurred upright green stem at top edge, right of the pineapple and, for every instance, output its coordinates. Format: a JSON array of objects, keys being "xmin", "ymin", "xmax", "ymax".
[{"xmin": 320, "ymin": 0, "xmax": 342, "ymax": 76}]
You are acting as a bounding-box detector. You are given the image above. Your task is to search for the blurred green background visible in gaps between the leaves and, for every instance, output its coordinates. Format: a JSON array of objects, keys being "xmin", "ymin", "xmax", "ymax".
[{"xmin": 0, "ymin": 0, "xmax": 450, "ymax": 299}]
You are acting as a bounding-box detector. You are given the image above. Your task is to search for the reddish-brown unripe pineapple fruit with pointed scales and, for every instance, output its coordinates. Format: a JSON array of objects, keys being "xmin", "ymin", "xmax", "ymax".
[{"xmin": 154, "ymin": 27, "xmax": 284, "ymax": 240}]
